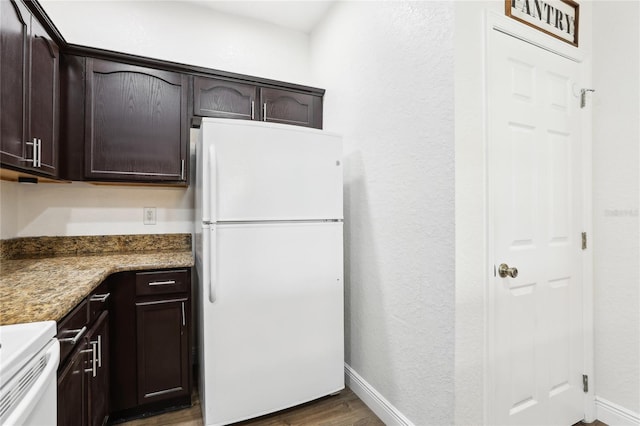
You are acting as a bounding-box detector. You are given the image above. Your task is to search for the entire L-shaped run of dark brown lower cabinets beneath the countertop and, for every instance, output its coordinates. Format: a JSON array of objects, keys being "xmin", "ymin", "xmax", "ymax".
[{"xmin": 57, "ymin": 269, "xmax": 193, "ymax": 426}]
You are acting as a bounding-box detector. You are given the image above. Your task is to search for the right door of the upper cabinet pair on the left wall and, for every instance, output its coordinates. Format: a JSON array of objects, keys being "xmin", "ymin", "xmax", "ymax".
[{"xmin": 29, "ymin": 19, "xmax": 60, "ymax": 176}]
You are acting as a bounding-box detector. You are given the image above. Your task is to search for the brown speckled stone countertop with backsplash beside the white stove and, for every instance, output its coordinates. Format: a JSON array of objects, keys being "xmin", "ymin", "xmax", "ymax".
[{"xmin": 0, "ymin": 234, "xmax": 194, "ymax": 325}]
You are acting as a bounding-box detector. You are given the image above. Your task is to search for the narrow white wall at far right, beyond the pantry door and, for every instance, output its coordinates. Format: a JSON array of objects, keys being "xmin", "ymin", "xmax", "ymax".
[{"xmin": 592, "ymin": 1, "xmax": 640, "ymax": 419}]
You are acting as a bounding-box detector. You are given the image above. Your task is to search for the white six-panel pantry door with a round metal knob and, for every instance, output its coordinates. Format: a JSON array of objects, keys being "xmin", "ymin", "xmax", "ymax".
[{"xmin": 487, "ymin": 30, "xmax": 583, "ymax": 426}]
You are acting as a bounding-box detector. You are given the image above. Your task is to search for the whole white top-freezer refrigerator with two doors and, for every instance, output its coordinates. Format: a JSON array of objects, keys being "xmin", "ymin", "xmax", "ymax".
[{"xmin": 195, "ymin": 118, "xmax": 344, "ymax": 425}]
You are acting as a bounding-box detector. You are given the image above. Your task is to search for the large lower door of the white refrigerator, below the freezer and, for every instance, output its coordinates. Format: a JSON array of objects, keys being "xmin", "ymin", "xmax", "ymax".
[{"xmin": 201, "ymin": 222, "xmax": 344, "ymax": 425}]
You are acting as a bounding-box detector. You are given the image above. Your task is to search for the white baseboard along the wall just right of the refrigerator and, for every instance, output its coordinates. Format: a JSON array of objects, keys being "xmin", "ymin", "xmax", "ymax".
[{"xmin": 344, "ymin": 363, "xmax": 415, "ymax": 426}]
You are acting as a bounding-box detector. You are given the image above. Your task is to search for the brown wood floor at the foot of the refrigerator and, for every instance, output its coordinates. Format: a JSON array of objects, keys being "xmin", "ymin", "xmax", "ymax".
[{"xmin": 122, "ymin": 388, "xmax": 384, "ymax": 426}]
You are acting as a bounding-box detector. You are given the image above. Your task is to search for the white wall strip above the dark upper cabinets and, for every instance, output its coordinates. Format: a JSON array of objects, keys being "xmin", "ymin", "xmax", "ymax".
[{"xmin": 41, "ymin": 0, "xmax": 309, "ymax": 84}]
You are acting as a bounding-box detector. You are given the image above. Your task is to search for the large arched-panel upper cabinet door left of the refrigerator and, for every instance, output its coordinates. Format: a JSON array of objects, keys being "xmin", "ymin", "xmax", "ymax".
[{"xmin": 85, "ymin": 59, "xmax": 188, "ymax": 182}]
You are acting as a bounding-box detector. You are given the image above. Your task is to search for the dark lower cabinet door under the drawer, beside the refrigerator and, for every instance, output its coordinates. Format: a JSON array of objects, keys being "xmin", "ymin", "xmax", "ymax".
[{"xmin": 136, "ymin": 297, "xmax": 189, "ymax": 404}]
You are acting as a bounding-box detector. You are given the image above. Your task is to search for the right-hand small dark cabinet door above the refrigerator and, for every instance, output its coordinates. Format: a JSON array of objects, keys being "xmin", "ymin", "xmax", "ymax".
[{"xmin": 260, "ymin": 88, "xmax": 322, "ymax": 129}]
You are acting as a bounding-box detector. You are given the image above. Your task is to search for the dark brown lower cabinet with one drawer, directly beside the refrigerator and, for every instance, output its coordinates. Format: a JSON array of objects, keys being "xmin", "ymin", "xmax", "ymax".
[{"xmin": 110, "ymin": 269, "xmax": 192, "ymax": 422}]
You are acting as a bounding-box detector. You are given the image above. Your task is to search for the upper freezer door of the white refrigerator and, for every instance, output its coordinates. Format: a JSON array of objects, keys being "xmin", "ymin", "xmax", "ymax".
[{"xmin": 199, "ymin": 119, "xmax": 342, "ymax": 222}]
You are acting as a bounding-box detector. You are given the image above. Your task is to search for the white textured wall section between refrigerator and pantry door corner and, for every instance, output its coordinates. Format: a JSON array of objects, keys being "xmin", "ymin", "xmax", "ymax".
[{"xmin": 311, "ymin": 1, "xmax": 455, "ymax": 425}]
